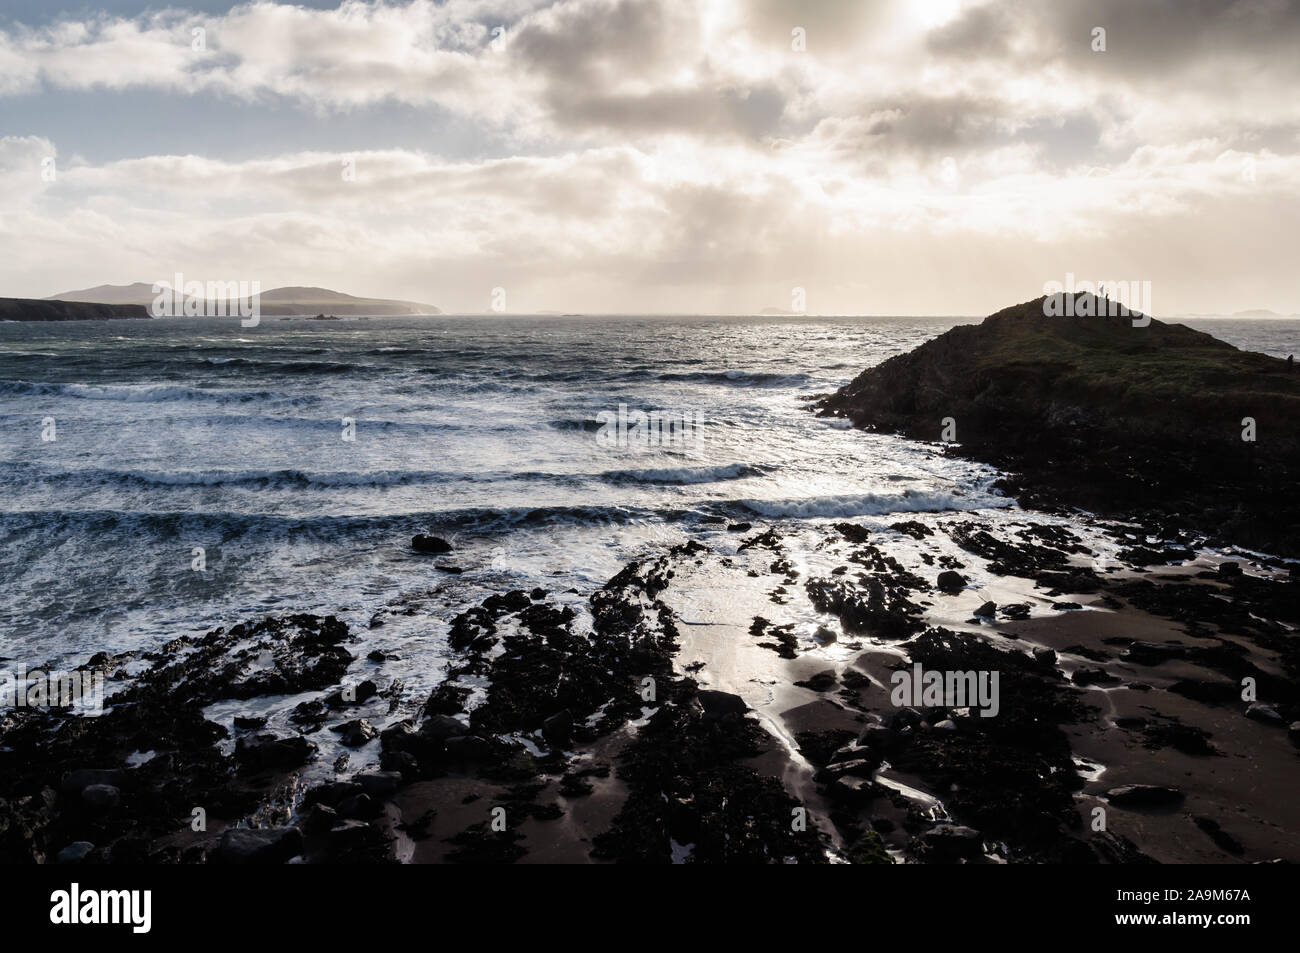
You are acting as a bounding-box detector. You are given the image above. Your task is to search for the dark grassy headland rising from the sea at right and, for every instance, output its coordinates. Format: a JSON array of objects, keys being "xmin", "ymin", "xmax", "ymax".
[{"xmin": 819, "ymin": 295, "xmax": 1300, "ymax": 554}]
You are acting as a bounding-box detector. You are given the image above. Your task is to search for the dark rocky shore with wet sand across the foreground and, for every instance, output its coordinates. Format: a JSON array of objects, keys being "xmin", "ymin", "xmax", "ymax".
[{"xmin": 0, "ymin": 499, "xmax": 1300, "ymax": 862}]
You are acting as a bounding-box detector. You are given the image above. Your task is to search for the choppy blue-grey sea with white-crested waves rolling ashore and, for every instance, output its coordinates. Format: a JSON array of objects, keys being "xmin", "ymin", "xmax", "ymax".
[{"xmin": 0, "ymin": 310, "xmax": 1300, "ymax": 688}]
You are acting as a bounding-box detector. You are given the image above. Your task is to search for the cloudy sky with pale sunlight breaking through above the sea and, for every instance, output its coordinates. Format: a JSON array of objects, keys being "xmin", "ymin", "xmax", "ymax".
[{"xmin": 0, "ymin": 0, "xmax": 1300, "ymax": 316}]
